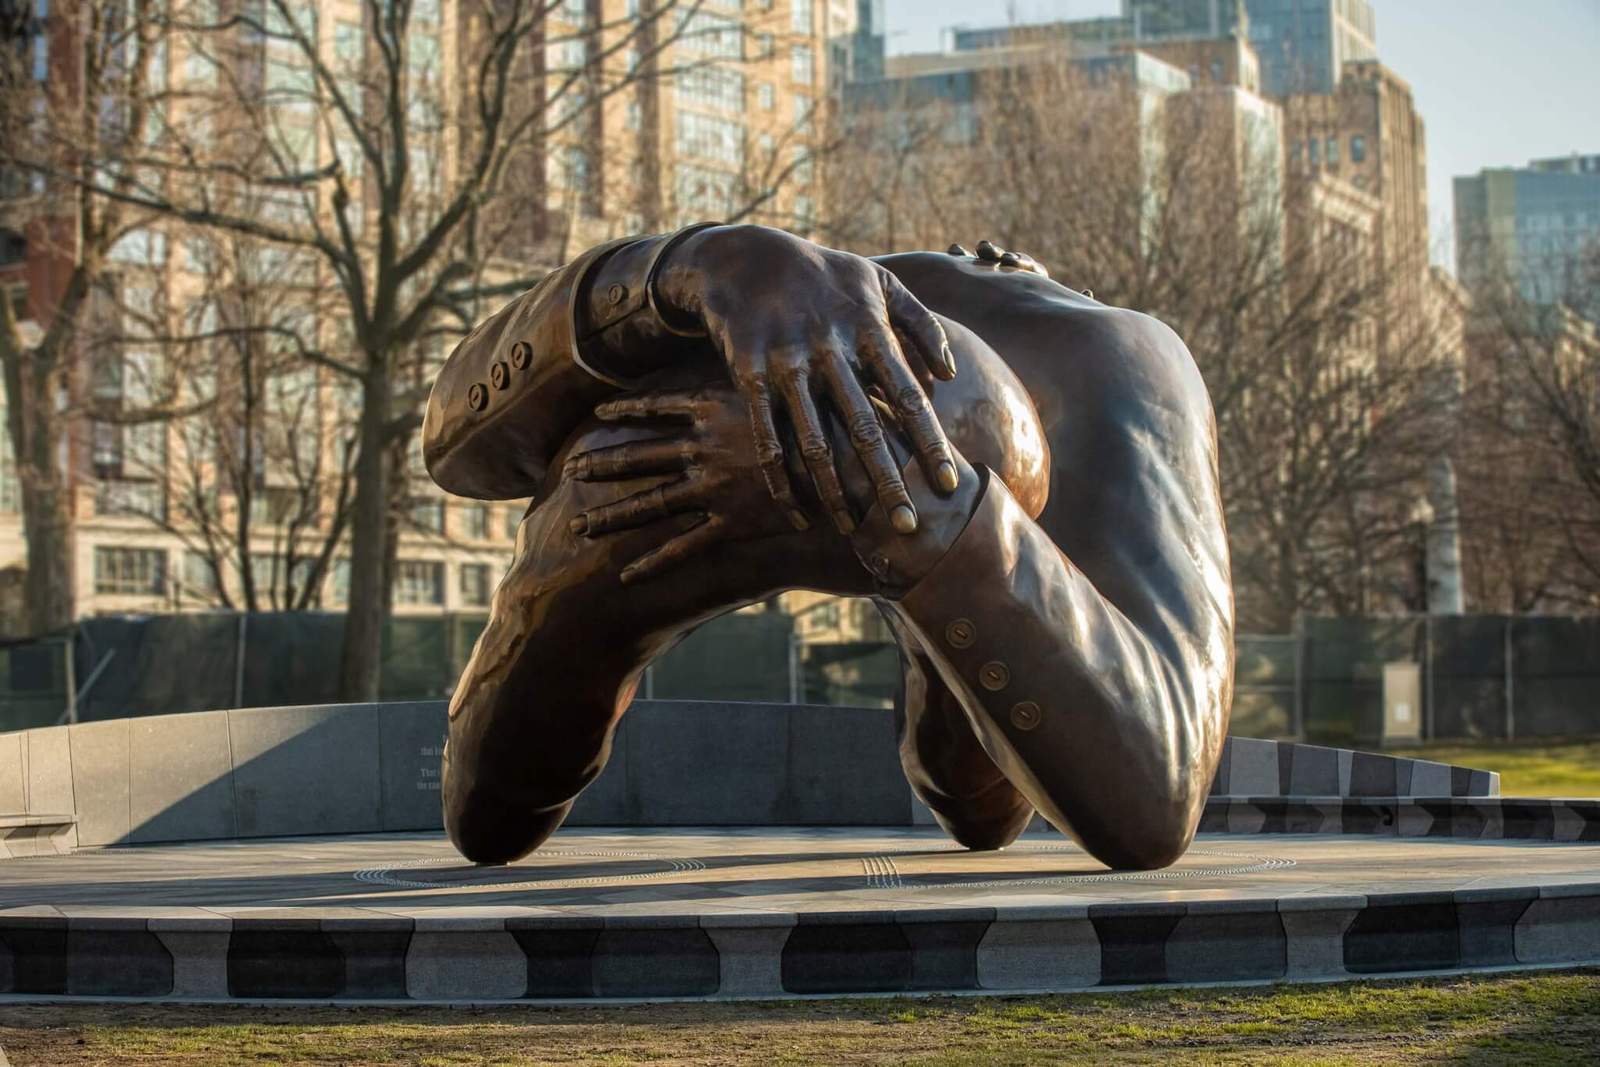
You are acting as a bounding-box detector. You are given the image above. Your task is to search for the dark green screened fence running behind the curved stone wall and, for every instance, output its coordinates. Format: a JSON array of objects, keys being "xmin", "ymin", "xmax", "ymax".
[{"xmin": 9, "ymin": 609, "xmax": 1600, "ymax": 747}]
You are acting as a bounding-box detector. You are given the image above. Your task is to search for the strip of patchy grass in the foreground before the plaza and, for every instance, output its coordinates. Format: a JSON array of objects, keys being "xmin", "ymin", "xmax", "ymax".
[{"xmin": 0, "ymin": 969, "xmax": 1600, "ymax": 1067}]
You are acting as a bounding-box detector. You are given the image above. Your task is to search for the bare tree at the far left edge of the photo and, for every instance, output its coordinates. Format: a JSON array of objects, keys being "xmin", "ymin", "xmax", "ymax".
[{"xmin": 0, "ymin": 0, "xmax": 209, "ymax": 633}]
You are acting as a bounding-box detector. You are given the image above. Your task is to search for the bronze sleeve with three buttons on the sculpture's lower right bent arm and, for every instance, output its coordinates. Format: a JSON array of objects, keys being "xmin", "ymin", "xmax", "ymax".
[{"xmin": 893, "ymin": 463, "xmax": 1232, "ymax": 869}]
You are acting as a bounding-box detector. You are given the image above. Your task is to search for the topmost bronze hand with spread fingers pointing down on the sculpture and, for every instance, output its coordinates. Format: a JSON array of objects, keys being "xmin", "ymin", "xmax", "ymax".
[{"xmin": 659, "ymin": 226, "xmax": 958, "ymax": 534}]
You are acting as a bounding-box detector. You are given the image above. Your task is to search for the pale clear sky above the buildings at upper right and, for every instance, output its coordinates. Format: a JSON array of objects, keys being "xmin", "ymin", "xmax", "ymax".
[{"xmin": 888, "ymin": 0, "xmax": 1600, "ymax": 267}]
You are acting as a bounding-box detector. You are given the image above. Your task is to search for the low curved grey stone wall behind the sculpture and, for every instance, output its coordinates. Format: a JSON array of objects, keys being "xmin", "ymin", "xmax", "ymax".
[{"xmin": 0, "ymin": 701, "xmax": 1499, "ymax": 846}]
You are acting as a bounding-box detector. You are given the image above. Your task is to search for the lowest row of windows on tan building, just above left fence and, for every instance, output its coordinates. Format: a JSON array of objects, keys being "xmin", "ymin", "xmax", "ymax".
[{"xmin": 94, "ymin": 545, "xmax": 494, "ymax": 608}]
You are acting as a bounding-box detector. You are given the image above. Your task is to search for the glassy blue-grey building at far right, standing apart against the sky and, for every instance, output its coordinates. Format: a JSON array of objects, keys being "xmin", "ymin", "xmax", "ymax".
[{"xmin": 1454, "ymin": 154, "xmax": 1600, "ymax": 322}]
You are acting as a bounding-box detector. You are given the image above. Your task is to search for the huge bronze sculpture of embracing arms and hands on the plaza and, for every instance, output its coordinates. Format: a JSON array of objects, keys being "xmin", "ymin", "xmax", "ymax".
[{"xmin": 424, "ymin": 226, "xmax": 1234, "ymax": 869}]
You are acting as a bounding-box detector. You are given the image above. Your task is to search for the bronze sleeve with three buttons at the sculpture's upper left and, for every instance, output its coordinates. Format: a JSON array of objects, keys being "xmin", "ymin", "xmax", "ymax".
[{"xmin": 422, "ymin": 228, "xmax": 704, "ymax": 501}]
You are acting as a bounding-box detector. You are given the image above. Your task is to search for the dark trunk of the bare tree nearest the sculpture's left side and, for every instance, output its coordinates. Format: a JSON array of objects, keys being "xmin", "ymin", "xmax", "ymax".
[{"xmin": 339, "ymin": 371, "xmax": 394, "ymax": 701}]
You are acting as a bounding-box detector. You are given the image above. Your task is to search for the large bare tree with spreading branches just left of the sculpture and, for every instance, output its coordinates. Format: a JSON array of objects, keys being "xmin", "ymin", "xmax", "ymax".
[{"xmin": 48, "ymin": 0, "xmax": 819, "ymax": 699}]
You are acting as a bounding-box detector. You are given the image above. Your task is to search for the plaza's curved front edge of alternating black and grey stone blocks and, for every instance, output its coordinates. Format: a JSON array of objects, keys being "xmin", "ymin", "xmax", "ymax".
[{"xmin": 0, "ymin": 885, "xmax": 1600, "ymax": 1000}]
